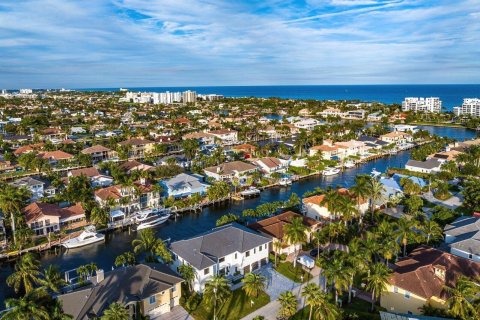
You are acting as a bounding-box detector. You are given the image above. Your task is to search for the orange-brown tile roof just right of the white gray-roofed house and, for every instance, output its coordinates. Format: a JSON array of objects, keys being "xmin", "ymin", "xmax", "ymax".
[{"xmin": 248, "ymin": 211, "xmax": 320, "ymax": 239}]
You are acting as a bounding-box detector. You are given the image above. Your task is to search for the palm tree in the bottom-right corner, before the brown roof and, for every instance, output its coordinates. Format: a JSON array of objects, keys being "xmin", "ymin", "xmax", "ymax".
[{"xmin": 445, "ymin": 275, "xmax": 479, "ymax": 319}]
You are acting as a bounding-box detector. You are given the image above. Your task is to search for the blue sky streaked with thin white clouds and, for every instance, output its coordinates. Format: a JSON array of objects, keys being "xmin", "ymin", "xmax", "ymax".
[{"xmin": 0, "ymin": 0, "xmax": 480, "ymax": 88}]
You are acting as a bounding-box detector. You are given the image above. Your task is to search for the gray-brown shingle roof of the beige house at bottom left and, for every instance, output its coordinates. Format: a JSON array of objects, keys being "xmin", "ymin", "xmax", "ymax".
[{"xmin": 58, "ymin": 263, "xmax": 183, "ymax": 320}]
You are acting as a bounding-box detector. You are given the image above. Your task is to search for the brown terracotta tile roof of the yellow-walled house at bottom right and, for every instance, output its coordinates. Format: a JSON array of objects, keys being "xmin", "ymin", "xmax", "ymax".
[{"xmin": 390, "ymin": 246, "xmax": 480, "ymax": 300}]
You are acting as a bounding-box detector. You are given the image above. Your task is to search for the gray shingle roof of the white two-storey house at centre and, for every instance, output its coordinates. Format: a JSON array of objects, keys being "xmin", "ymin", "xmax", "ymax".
[{"xmin": 170, "ymin": 223, "xmax": 271, "ymax": 270}]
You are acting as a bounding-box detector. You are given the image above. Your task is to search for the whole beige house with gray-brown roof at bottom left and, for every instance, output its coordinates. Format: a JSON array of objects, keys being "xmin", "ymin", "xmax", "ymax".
[{"xmin": 58, "ymin": 263, "xmax": 183, "ymax": 320}]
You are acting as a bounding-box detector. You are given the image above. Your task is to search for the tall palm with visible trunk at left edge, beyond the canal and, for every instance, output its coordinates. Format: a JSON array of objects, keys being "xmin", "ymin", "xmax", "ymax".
[{"xmin": 0, "ymin": 184, "xmax": 30, "ymax": 244}]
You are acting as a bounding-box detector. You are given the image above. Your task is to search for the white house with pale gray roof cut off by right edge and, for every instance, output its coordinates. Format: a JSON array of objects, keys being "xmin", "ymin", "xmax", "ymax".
[{"xmin": 444, "ymin": 216, "xmax": 480, "ymax": 262}]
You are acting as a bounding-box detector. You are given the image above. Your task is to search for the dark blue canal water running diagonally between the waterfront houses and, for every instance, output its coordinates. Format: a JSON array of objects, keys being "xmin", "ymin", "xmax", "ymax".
[{"xmin": 0, "ymin": 127, "xmax": 475, "ymax": 304}]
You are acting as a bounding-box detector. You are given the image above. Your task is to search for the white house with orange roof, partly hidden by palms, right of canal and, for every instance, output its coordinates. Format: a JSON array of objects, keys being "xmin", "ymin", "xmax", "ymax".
[{"xmin": 302, "ymin": 188, "xmax": 369, "ymax": 221}]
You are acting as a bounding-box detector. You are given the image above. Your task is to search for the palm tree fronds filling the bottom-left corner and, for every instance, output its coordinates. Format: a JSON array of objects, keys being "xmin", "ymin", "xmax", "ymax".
[{"xmin": 2, "ymin": 289, "xmax": 51, "ymax": 320}]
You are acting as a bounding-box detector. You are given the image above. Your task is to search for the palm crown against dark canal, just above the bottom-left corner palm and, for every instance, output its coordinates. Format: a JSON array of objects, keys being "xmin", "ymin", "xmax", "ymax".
[{"xmin": 7, "ymin": 253, "xmax": 42, "ymax": 293}]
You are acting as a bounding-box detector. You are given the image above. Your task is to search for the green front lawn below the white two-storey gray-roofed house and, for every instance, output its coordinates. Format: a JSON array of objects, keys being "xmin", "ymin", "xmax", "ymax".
[{"xmin": 192, "ymin": 288, "xmax": 270, "ymax": 320}]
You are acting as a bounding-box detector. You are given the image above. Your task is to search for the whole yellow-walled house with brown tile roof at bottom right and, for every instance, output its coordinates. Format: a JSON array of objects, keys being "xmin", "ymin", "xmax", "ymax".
[{"xmin": 380, "ymin": 246, "xmax": 480, "ymax": 314}]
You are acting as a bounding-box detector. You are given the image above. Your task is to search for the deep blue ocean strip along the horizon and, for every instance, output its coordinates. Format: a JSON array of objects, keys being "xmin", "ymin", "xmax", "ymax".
[{"xmin": 78, "ymin": 84, "xmax": 480, "ymax": 111}]
